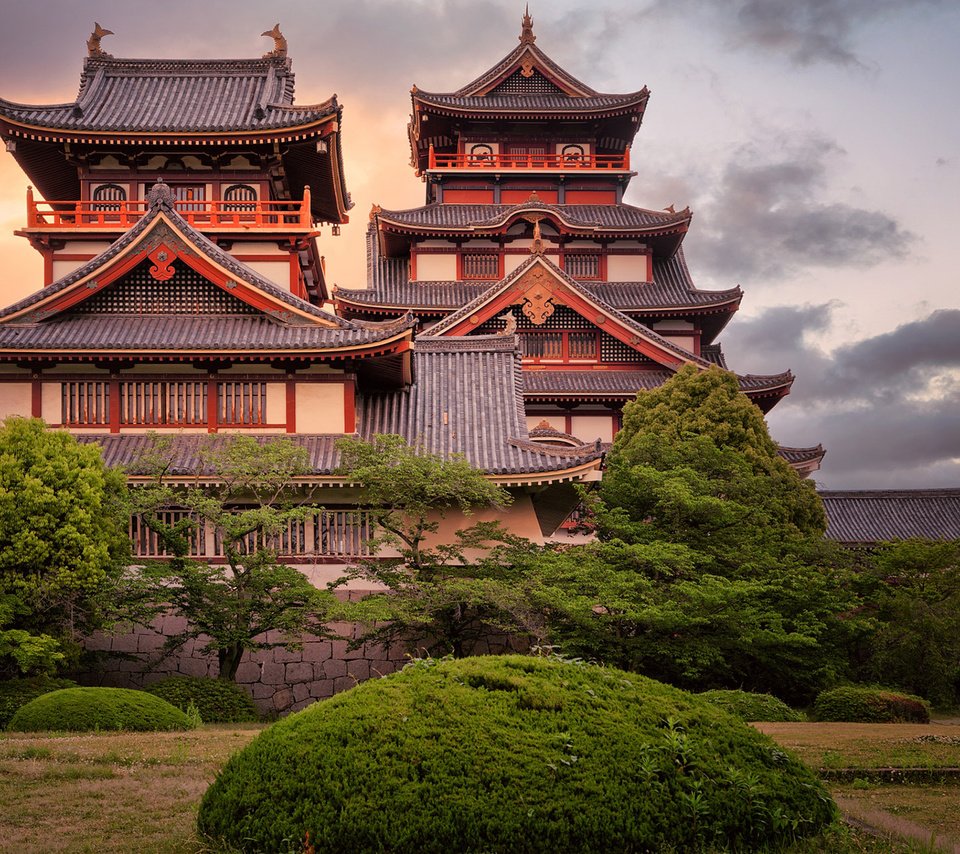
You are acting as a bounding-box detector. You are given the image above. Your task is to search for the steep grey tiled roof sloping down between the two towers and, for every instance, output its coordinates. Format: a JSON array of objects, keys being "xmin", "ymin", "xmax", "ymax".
[{"xmin": 358, "ymin": 335, "xmax": 600, "ymax": 474}]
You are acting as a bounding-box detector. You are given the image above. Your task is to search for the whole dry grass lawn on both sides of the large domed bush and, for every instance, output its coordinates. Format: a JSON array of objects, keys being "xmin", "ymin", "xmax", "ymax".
[{"xmin": 0, "ymin": 724, "xmax": 960, "ymax": 854}]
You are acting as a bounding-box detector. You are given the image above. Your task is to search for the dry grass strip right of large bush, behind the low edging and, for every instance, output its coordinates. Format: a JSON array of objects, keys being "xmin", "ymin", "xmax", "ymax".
[{"xmin": 754, "ymin": 723, "xmax": 960, "ymax": 769}]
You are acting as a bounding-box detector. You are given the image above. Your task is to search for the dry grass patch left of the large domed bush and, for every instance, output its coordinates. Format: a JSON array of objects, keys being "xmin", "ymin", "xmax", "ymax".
[{"xmin": 0, "ymin": 724, "xmax": 262, "ymax": 854}]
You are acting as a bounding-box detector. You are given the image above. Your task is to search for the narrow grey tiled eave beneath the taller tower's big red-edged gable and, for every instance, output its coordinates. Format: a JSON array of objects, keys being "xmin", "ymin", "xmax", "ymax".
[{"xmin": 523, "ymin": 370, "xmax": 793, "ymax": 398}]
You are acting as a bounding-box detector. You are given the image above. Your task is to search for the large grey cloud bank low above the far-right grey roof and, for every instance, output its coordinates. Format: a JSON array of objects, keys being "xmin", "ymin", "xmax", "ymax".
[{"xmin": 727, "ymin": 303, "xmax": 960, "ymax": 489}]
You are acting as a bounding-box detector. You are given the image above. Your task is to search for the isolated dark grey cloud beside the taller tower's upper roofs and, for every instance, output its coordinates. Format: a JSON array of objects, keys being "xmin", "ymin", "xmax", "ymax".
[{"xmin": 690, "ymin": 136, "xmax": 915, "ymax": 283}]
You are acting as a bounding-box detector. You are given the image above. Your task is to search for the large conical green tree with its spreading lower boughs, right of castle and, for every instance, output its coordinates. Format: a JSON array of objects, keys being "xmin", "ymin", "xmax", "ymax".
[{"xmin": 516, "ymin": 367, "xmax": 864, "ymax": 701}]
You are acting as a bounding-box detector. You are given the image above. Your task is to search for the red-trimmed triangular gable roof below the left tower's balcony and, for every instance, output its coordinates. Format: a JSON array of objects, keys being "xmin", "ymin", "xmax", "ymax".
[{"xmin": 0, "ymin": 183, "xmax": 415, "ymax": 360}]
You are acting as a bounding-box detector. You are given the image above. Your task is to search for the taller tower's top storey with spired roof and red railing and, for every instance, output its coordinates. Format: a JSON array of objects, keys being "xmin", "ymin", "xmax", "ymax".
[{"xmin": 409, "ymin": 8, "xmax": 650, "ymax": 204}]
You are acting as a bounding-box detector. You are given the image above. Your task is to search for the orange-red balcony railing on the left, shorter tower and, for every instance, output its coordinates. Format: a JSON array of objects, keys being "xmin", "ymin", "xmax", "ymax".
[{"xmin": 27, "ymin": 187, "xmax": 313, "ymax": 231}]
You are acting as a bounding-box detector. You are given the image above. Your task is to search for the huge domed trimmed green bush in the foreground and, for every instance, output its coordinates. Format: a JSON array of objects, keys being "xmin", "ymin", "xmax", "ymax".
[{"xmin": 198, "ymin": 655, "xmax": 835, "ymax": 853}]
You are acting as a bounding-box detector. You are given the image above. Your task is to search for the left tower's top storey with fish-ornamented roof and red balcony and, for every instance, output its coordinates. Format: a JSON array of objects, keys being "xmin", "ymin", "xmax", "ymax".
[{"xmin": 0, "ymin": 24, "xmax": 350, "ymax": 230}]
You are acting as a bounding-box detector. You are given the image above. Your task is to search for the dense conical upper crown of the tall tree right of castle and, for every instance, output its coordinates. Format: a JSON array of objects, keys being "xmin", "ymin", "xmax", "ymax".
[{"xmin": 598, "ymin": 366, "xmax": 826, "ymax": 575}]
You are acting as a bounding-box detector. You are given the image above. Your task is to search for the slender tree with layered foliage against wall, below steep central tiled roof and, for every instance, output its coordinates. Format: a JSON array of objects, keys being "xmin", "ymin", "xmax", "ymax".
[{"xmin": 338, "ymin": 435, "xmax": 532, "ymax": 656}]
